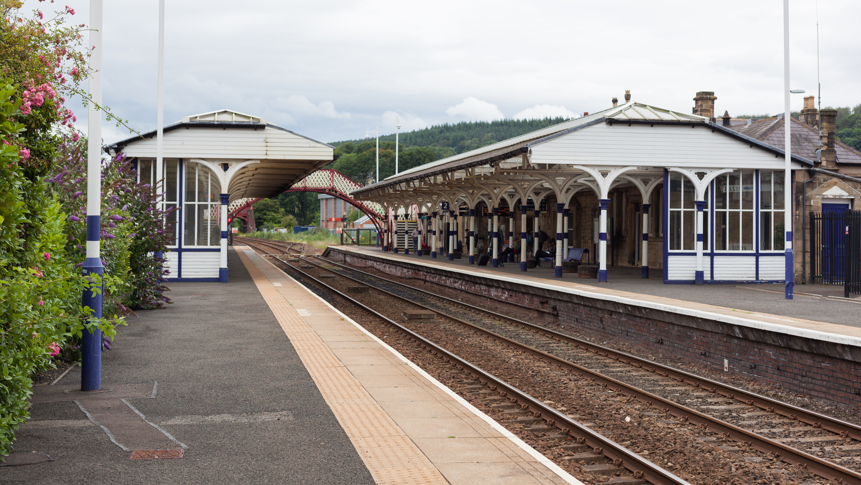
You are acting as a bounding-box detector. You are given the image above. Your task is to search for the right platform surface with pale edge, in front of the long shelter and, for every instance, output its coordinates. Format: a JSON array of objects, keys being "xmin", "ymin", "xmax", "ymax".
[{"xmin": 332, "ymin": 246, "xmax": 861, "ymax": 346}]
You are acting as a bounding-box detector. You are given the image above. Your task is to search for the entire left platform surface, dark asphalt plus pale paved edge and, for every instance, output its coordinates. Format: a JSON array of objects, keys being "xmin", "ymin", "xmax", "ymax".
[{"xmin": 5, "ymin": 247, "xmax": 580, "ymax": 484}]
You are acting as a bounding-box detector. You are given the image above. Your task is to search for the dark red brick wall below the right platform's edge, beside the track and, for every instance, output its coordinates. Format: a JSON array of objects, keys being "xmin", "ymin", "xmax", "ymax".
[{"xmin": 329, "ymin": 250, "xmax": 861, "ymax": 404}]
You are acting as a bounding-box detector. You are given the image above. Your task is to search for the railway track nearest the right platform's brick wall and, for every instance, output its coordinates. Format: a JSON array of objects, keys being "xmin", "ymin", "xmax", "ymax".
[{"xmin": 235, "ymin": 236, "xmax": 861, "ymax": 483}]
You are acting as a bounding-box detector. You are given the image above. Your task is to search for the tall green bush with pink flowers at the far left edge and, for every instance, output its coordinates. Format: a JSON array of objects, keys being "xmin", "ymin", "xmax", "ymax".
[{"xmin": 0, "ymin": 0, "xmax": 128, "ymax": 456}]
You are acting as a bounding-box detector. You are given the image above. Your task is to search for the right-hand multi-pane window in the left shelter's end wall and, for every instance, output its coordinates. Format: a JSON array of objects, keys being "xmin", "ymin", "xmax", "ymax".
[{"xmin": 182, "ymin": 163, "xmax": 221, "ymax": 247}]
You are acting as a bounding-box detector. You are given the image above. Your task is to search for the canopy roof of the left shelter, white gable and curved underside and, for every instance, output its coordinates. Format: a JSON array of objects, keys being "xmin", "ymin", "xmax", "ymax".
[{"xmin": 106, "ymin": 109, "xmax": 335, "ymax": 201}]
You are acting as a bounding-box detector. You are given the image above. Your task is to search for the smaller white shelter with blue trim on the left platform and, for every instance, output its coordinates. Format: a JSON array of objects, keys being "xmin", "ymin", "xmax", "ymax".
[{"xmin": 108, "ymin": 110, "xmax": 334, "ymax": 281}]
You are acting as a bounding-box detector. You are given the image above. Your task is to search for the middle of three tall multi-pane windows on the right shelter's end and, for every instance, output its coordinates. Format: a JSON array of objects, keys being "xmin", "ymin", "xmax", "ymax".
[{"xmin": 715, "ymin": 170, "xmax": 756, "ymax": 251}]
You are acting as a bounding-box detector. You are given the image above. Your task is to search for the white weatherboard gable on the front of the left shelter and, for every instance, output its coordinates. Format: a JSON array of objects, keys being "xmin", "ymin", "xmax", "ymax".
[{"xmin": 123, "ymin": 126, "xmax": 333, "ymax": 160}]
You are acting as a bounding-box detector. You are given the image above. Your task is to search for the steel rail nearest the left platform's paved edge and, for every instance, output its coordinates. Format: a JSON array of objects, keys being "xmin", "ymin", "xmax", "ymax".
[{"xmin": 249, "ymin": 240, "xmax": 690, "ymax": 485}]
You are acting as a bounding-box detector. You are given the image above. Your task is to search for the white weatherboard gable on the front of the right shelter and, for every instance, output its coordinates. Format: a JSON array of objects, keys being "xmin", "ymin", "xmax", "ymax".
[{"xmin": 529, "ymin": 122, "xmax": 801, "ymax": 170}]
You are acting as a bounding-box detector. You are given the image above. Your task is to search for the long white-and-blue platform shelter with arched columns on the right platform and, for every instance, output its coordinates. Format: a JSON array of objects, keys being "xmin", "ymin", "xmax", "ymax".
[{"xmin": 352, "ymin": 100, "xmax": 813, "ymax": 284}]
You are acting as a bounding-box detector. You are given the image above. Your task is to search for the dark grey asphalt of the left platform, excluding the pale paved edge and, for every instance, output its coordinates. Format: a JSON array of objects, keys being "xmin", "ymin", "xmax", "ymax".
[{"xmin": 0, "ymin": 250, "xmax": 373, "ymax": 484}]
